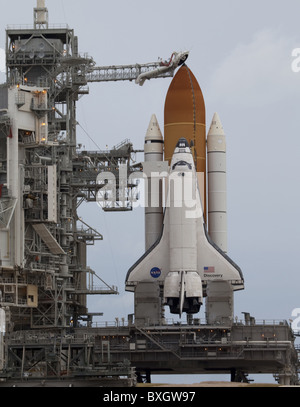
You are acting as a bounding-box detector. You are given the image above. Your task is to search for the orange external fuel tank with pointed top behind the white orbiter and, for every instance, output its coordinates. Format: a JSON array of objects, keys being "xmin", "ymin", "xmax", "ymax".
[{"xmin": 164, "ymin": 65, "xmax": 206, "ymax": 220}]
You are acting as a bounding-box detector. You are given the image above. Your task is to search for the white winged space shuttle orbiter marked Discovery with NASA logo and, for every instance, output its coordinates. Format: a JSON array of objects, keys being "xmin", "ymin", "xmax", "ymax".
[{"xmin": 126, "ymin": 138, "xmax": 244, "ymax": 315}]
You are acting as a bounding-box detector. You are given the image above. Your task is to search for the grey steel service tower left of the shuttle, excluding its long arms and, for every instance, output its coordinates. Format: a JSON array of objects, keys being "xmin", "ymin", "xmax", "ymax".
[{"xmin": 0, "ymin": 1, "xmax": 117, "ymax": 329}]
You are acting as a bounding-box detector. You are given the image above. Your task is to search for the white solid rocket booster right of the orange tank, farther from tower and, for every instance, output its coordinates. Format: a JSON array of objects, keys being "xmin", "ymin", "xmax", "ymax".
[{"xmin": 207, "ymin": 113, "xmax": 227, "ymax": 253}]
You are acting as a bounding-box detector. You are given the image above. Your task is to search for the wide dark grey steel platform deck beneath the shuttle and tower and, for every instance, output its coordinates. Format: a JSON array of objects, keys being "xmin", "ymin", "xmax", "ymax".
[{"xmin": 0, "ymin": 321, "xmax": 298, "ymax": 387}]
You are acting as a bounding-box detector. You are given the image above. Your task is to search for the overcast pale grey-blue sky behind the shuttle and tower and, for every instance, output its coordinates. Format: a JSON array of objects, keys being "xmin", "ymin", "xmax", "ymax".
[{"xmin": 0, "ymin": 0, "xmax": 300, "ymax": 382}]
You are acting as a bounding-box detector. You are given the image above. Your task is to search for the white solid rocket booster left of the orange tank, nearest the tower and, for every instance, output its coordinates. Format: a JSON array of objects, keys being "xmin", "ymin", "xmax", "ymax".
[{"xmin": 143, "ymin": 114, "xmax": 163, "ymax": 250}]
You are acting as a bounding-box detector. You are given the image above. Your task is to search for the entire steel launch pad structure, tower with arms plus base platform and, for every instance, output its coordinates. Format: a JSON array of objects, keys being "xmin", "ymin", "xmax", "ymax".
[{"xmin": 0, "ymin": 1, "xmax": 298, "ymax": 387}]
